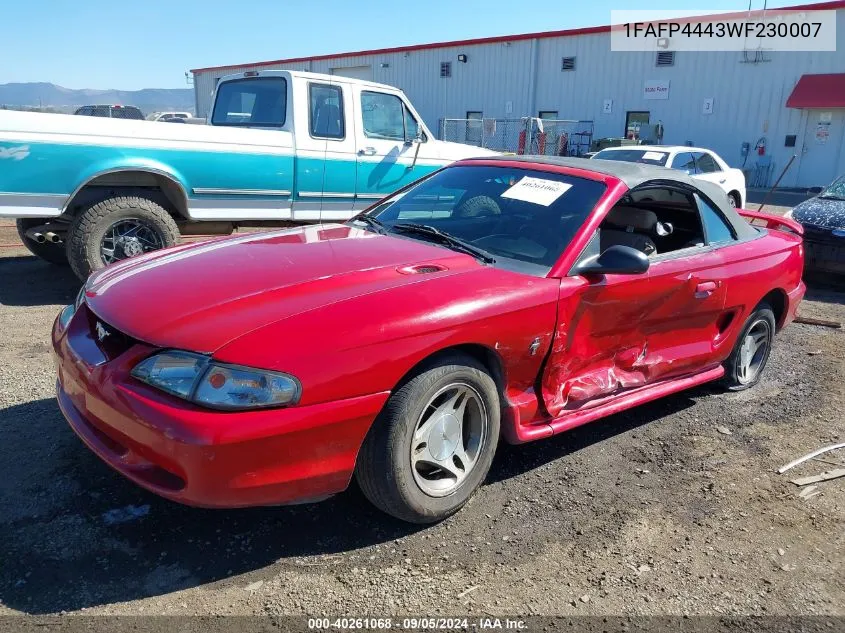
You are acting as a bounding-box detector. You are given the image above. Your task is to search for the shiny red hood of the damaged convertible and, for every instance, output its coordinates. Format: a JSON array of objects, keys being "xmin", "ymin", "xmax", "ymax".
[{"xmin": 86, "ymin": 225, "xmax": 482, "ymax": 353}]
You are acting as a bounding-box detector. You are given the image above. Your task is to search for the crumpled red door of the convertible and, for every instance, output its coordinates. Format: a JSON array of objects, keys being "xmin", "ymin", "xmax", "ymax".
[{"xmin": 542, "ymin": 250, "xmax": 726, "ymax": 417}]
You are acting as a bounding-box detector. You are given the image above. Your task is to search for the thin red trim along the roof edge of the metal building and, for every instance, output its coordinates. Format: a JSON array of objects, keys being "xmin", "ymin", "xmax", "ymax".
[{"xmin": 191, "ymin": 0, "xmax": 845, "ymax": 73}]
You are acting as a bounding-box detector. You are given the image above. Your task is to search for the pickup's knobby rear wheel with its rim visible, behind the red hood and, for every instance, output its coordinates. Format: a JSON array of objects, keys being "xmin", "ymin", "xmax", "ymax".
[{"xmin": 67, "ymin": 196, "xmax": 179, "ymax": 280}]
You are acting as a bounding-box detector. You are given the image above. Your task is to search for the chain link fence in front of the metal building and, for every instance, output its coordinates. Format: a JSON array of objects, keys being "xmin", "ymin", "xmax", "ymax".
[{"xmin": 440, "ymin": 117, "xmax": 593, "ymax": 156}]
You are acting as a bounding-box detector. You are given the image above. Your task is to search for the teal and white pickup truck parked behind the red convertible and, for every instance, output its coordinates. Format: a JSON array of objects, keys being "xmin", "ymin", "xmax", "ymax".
[{"xmin": 0, "ymin": 70, "xmax": 490, "ymax": 279}]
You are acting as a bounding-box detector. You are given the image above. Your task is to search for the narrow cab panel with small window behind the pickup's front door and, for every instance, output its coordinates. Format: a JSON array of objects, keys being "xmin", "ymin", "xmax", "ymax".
[{"xmin": 293, "ymin": 80, "xmax": 358, "ymax": 220}]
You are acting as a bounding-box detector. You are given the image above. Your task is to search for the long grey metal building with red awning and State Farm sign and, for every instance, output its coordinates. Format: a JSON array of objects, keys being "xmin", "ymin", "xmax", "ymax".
[{"xmin": 192, "ymin": 0, "xmax": 845, "ymax": 187}]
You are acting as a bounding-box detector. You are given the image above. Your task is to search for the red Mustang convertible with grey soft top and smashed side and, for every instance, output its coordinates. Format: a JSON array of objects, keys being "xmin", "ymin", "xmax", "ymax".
[{"xmin": 53, "ymin": 157, "xmax": 804, "ymax": 523}]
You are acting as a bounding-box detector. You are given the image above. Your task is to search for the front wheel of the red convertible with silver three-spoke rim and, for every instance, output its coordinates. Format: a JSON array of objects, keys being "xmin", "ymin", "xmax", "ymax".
[{"xmin": 355, "ymin": 354, "xmax": 501, "ymax": 523}]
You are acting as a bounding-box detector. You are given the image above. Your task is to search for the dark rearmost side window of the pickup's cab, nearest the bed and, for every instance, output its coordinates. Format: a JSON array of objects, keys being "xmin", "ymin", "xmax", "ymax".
[{"xmin": 211, "ymin": 77, "xmax": 288, "ymax": 127}]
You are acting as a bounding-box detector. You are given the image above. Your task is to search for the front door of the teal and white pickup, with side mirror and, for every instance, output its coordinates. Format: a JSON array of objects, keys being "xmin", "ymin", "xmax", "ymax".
[{"xmin": 355, "ymin": 88, "xmax": 435, "ymax": 208}]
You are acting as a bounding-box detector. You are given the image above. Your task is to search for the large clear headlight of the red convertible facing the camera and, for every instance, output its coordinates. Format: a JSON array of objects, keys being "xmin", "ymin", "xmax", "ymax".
[{"xmin": 132, "ymin": 351, "xmax": 301, "ymax": 410}]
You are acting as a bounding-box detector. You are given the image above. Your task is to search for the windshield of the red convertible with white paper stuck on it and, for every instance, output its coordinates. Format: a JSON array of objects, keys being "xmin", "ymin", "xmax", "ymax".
[{"xmin": 353, "ymin": 165, "xmax": 606, "ymax": 276}]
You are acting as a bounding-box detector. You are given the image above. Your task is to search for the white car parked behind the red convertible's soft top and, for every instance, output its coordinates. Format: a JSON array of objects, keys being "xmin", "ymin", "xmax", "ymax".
[{"xmin": 592, "ymin": 145, "xmax": 746, "ymax": 208}]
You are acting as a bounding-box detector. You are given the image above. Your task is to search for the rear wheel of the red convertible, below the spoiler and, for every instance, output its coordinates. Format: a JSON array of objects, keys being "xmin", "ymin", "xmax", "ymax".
[{"xmin": 722, "ymin": 303, "xmax": 776, "ymax": 391}]
